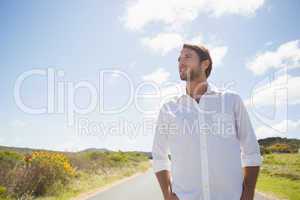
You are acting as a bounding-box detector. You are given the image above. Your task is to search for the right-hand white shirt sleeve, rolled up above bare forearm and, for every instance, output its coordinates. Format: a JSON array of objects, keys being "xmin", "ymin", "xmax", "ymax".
[{"xmin": 235, "ymin": 95, "xmax": 263, "ymax": 167}]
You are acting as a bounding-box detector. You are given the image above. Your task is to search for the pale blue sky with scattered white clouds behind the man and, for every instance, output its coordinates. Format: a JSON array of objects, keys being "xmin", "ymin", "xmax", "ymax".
[{"xmin": 0, "ymin": 0, "xmax": 300, "ymax": 151}]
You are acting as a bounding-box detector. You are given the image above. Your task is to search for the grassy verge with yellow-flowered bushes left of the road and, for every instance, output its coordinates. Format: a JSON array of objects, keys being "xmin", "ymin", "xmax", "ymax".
[{"xmin": 0, "ymin": 150, "xmax": 151, "ymax": 200}]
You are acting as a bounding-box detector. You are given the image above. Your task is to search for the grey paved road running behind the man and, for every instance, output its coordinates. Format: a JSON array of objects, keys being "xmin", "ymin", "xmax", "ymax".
[{"xmin": 88, "ymin": 170, "xmax": 267, "ymax": 200}]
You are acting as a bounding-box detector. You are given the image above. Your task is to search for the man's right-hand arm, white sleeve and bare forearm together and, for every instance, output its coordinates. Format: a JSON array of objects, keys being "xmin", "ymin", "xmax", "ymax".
[{"xmin": 235, "ymin": 96, "xmax": 262, "ymax": 200}]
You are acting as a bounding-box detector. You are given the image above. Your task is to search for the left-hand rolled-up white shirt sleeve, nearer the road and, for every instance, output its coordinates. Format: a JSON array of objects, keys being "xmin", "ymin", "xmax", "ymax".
[{"xmin": 152, "ymin": 106, "xmax": 171, "ymax": 172}]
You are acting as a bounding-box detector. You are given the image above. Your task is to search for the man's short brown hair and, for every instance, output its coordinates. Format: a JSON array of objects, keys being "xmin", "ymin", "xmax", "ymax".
[{"xmin": 183, "ymin": 44, "xmax": 212, "ymax": 78}]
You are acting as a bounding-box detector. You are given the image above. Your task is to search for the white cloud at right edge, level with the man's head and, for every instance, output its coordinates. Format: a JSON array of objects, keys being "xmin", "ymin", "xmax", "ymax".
[{"xmin": 247, "ymin": 40, "xmax": 300, "ymax": 75}]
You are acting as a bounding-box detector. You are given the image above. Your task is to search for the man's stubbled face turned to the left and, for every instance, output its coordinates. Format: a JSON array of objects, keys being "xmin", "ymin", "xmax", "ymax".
[{"xmin": 178, "ymin": 48, "xmax": 202, "ymax": 81}]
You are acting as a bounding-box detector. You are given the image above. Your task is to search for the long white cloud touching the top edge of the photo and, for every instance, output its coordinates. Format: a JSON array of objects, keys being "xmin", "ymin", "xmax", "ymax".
[{"xmin": 122, "ymin": 0, "xmax": 264, "ymax": 30}]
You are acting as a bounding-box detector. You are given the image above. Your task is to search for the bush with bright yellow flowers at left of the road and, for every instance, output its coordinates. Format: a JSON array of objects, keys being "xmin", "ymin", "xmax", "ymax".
[{"xmin": 13, "ymin": 151, "xmax": 76, "ymax": 198}]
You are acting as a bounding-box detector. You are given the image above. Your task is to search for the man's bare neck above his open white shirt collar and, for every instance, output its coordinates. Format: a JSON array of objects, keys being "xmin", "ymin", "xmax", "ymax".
[{"xmin": 186, "ymin": 79, "xmax": 208, "ymax": 101}]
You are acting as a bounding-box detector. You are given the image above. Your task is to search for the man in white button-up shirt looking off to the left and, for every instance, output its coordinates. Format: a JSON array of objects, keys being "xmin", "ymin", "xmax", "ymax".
[{"xmin": 152, "ymin": 44, "xmax": 262, "ymax": 200}]
